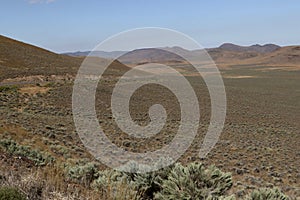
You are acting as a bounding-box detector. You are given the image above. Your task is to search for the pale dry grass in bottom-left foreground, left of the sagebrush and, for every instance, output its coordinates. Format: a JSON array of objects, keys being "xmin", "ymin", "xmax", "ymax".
[{"xmin": 0, "ymin": 163, "xmax": 138, "ymax": 200}]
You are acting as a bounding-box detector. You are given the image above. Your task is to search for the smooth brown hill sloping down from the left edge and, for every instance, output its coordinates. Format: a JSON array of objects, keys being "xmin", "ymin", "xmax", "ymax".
[{"xmin": 0, "ymin": 35, "xmax": 127, "ymax": 81}]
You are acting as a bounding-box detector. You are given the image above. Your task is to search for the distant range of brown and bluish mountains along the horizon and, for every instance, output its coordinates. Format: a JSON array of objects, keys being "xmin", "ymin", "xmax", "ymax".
[{"xmin": 61, "ymin": 43, "xmax": 300, "ymax": 67}]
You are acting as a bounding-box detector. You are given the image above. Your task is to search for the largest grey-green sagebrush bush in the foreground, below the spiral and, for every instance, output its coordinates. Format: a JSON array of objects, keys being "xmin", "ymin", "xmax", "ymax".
[{"xmin": 155, "ymin": 163, "xmax": 232, "ymax": 199}]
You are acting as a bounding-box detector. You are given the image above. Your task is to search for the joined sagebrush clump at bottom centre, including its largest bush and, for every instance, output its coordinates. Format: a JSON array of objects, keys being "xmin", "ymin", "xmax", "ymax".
[{"xmin": 93, "ymin": 163, "xmax": 234, "ymax": 200}]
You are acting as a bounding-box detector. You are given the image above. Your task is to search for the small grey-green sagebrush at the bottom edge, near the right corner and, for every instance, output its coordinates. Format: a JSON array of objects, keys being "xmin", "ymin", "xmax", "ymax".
[{"xmin": 246, "ymin": 188, "xmax": 289, "ymax": 200}]
